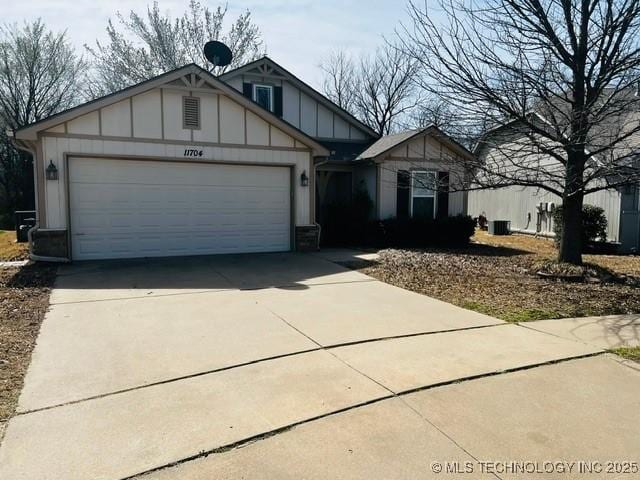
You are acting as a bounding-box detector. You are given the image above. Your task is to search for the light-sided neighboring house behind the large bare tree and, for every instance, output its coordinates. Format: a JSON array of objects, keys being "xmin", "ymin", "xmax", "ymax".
[{"xmin": 468, "ymin": 117, "xmax": 640, "ymax": 252}]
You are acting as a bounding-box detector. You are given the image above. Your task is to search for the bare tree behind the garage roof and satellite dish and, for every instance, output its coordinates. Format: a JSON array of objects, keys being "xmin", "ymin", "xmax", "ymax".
[{"xmin": 85, "ymin": 0, "xmax": 264, "ymax": 96}]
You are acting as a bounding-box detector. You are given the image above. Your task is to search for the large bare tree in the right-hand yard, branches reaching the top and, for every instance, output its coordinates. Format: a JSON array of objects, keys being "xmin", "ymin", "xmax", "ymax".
[{"xmin": 400, "ymin": 0, "xmax": 640, "ymax": 264}]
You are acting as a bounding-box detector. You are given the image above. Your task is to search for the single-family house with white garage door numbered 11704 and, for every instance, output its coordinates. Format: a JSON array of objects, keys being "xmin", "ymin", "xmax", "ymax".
[{"xmin": 14, "ymin": 57, "xmax": 471, "ymax": 260}]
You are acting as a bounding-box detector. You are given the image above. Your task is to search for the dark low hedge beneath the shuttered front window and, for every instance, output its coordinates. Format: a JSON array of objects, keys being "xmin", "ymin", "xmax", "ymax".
[{"xmin": 365, "ymin": 215, "xmax": 475, "ymax": 248}]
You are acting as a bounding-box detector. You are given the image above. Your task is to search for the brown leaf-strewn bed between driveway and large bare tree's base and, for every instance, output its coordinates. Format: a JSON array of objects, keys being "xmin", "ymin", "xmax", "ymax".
[{"xmin": 362, "ymin": 248, "xmax": 640, "ymax": 321}]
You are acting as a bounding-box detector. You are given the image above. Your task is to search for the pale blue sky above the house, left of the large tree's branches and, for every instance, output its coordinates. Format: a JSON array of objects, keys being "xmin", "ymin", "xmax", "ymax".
[{"xmin": 2, "ymin": 0, "xmax": 416, "ymax": 88}]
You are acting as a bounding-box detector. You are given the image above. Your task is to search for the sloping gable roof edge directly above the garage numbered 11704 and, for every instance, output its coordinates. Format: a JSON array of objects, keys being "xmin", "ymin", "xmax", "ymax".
[{"xmin": 15, "ymin": 63, "xmax": 329, "ymax": 157}]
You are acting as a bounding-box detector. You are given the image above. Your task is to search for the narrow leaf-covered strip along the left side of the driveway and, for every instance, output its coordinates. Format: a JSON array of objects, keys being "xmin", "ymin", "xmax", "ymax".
[{"xmin": 0, "ymin": 264, "xmax": 56, "ymax": 438}]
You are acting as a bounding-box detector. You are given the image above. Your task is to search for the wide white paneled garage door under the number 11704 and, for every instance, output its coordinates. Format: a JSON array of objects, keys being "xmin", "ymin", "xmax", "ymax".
[{"xmin": 69, "ymin": 158, "xmax": 291, "ymax": 260}]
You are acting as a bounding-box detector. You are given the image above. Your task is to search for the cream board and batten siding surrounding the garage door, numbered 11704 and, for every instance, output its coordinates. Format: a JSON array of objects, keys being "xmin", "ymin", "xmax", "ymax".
[{"xmin": 38, "ymin": 87, "xmax": 313, "ymax": 229}]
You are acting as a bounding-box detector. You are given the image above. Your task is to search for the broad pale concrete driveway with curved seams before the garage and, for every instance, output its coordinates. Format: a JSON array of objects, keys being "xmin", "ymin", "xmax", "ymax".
[{"xmin": 0, "ymin": 249, "xmax": 640, "ymax": 480}]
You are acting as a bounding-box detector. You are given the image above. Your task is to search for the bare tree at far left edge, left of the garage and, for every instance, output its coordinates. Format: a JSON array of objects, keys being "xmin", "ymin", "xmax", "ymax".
[{"xmin": 0, "ymin": 20, "xmax": 86, "ymax": 223}]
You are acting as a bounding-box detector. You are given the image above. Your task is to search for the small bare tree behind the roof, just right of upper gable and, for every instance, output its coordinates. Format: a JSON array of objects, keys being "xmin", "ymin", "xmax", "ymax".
[{"xmin": 320, "ymin": 51, "xmax": 356, "ymax": 112}]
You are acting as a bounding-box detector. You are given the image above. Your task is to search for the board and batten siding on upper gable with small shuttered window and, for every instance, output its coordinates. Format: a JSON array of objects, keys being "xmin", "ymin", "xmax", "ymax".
[{"xmin": 227, "ymin": 73, "xmax": 369, "ymax": 141}]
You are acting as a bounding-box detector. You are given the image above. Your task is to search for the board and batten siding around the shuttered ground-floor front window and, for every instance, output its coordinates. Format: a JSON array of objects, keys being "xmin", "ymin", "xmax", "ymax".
[{"xmin": 378, "ymin": 135, "xmax": 467, "ymax": 219}]
